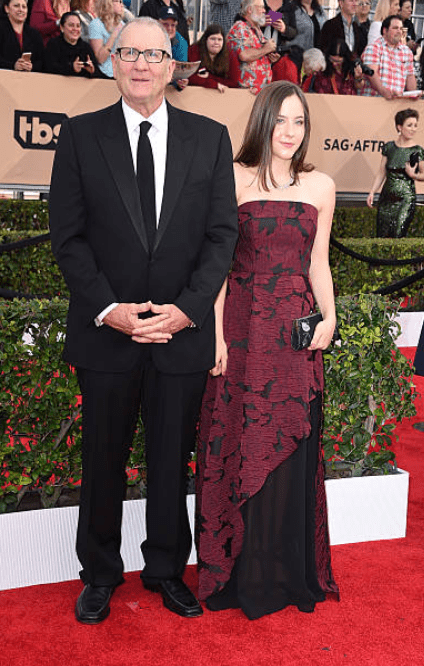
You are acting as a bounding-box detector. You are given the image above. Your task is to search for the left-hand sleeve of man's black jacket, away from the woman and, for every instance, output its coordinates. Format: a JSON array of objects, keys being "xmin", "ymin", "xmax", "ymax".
[{"xmin": 49, "ymin": 121, "xmax": 119, "ymax": 323}]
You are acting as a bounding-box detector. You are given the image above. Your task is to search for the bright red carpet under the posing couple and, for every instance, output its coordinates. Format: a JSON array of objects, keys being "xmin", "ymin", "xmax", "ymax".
[{"xmin": 0, "ymin": 350, "xmax": 424, "ymax": 666}]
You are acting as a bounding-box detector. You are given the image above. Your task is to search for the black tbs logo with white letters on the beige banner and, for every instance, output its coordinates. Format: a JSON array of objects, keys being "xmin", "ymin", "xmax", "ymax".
[{"xmin": 13, "ymin": 111, "xmax": 68, "ymax": 150}]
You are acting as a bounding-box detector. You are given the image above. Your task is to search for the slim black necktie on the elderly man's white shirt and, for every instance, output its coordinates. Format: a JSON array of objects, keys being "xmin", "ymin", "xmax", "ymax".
[{"xmin": 137, "ymin": 120, "xmax": 156, "ymax": 251}]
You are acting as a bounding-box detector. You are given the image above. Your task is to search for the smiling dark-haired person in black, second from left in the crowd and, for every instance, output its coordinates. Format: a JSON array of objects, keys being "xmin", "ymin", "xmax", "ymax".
[{"xmin": 44, "ymin": 12, "xmax": 103, "ymax": 78}]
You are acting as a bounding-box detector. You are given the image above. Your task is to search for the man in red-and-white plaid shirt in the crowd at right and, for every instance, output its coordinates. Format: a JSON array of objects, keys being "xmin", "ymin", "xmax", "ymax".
[{"xmin": 358, "ymin": 15, "xmax": 417, "ymax": 99}]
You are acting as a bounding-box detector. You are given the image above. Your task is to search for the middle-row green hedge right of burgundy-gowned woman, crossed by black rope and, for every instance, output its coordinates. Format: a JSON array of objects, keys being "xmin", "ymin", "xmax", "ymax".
[{"xmin": 330, "ymin": 238, "xmax": 424, "ymax": 309}]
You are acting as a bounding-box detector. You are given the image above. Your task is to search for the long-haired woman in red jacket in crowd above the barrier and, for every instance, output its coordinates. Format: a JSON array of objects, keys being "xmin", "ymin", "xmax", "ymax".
[{"xmin": 188, "ymin": 23, "xmax": 239, "ymax": 92}]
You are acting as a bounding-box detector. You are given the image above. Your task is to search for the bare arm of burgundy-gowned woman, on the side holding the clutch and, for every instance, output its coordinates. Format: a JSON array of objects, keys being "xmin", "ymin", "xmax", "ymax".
[{"xmin": 308, "ymin": 174, "xmax": 336, "ymax": 349}]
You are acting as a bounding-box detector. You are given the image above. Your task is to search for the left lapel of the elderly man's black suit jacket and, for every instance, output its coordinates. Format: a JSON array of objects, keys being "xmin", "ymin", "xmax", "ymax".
[{"xmin": 98, "ymin": 101, "xmax": 149, "ymax": 252}]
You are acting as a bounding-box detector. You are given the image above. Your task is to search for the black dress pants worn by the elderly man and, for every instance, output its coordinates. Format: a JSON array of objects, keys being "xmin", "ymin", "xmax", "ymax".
[{"xmin": 77, "ymin": 355, "xmax": 207, "ymax": 585}]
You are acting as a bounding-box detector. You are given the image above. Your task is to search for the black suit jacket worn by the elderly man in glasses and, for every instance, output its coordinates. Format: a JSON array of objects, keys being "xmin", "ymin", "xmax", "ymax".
[{"xmin": 50, "ymin": 102, "xmax": 237, "ymax": 373}]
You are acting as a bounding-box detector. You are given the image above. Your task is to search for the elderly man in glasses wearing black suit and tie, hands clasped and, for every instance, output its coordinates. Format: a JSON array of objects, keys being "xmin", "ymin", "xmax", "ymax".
[{"xmin": 50, "ymin": 18, "xmax": 237, "ymax": 624}]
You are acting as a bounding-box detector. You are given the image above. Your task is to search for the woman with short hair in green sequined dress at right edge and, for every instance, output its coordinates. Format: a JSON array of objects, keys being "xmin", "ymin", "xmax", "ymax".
[{"xmin": 367, "ymin": 109, "xmax": 424, "ymax": 238}]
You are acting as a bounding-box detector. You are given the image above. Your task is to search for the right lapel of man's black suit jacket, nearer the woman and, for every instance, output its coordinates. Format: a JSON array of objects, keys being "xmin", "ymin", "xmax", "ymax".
[{"xmin": 154, "ymin": 104, "xmax": 194, "ymax": 250}]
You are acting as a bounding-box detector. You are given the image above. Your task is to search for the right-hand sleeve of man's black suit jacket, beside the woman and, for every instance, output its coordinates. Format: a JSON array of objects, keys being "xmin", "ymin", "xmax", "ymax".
[{"xmin": 175, "ymin": 127, "xmax": 238, "ymax": 328}]
